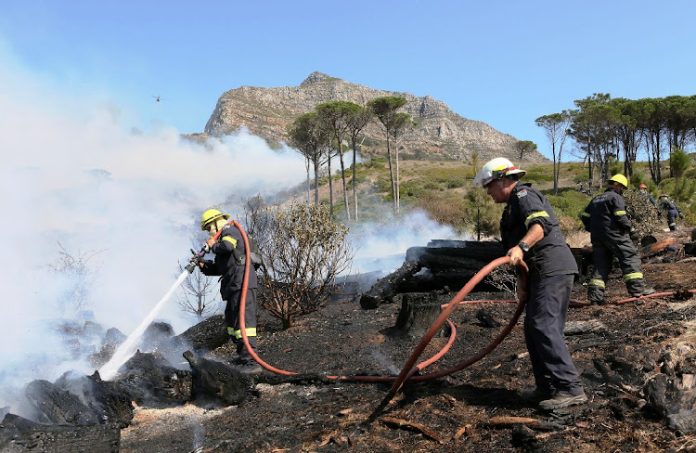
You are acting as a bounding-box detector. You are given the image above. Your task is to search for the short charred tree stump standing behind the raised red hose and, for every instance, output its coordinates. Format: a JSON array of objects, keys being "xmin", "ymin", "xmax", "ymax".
[{"xmin": 389, "ymin": 293, "xmax": 442, "ymax": 337}]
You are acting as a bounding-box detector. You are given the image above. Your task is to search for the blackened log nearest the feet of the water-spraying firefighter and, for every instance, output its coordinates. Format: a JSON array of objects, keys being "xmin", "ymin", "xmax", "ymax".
[{"xmin": 184, "ymin": 351, "xmax": 255, "ymax": 407}]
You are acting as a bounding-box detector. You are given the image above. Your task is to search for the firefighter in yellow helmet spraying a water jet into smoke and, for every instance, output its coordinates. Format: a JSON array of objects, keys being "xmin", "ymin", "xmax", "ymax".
[{"xmin": 199, "ymin": 209, "xmax": 260, "ymax": 370}]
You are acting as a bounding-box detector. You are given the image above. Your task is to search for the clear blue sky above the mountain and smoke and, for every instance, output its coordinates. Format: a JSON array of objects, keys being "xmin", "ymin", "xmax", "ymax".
[{"xmin": 0, "ymin": 0, "xmax": 696, "ymax": 159}]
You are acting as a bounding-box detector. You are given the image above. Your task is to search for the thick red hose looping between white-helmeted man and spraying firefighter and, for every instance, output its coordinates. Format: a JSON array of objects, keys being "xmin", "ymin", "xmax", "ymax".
[{"xmin": 229, "ymin": 220, "xmax": 527, "ymax": 384}]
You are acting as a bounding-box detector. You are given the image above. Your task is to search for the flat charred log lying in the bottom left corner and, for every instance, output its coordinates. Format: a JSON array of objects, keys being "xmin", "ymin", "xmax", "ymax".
[{"xmin": 0, "ymin": 414, "xmax": 121, "ymax": 453}]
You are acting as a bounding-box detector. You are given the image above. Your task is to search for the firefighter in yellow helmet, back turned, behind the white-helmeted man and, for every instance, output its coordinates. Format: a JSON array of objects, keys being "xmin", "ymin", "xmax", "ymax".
[{"xmin": 581, "ymin": 174, "xmax": 655, "ymax": 304}]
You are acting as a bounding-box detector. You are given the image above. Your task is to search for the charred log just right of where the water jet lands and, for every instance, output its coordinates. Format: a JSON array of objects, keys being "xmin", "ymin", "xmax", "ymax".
[{"xmin": 116, "ymin": 351, "xmax": 191, "ymax": 407}]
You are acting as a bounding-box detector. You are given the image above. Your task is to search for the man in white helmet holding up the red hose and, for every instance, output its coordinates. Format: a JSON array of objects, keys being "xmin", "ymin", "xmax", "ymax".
[{"xmin": 474, "ymin": 158, "xmax": 587, "ymax": 410}]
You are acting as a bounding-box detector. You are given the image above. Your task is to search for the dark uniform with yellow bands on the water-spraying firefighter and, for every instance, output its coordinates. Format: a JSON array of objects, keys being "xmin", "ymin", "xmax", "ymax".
[{"xmin": 201, "ymin": 225, "xmax": 258, "ymax": 359}]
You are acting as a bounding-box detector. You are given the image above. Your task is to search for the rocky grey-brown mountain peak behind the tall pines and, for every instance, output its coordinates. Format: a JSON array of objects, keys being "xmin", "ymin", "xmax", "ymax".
[{"xmin": 198, "ymin": 72, "xmax": 545, "ymax": 161}]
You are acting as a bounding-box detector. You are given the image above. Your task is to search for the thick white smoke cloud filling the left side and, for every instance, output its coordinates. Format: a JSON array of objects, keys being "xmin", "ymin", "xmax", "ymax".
[{"xmin": 0, "ymin": 45, "xmax": 305, "ymax": 407}]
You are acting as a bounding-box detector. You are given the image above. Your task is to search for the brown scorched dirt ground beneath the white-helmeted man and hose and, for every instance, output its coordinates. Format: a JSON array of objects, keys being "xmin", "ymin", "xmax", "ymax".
[{"xmin": 121, "ymin": 252, "xmax": 696, "ymax": 452}]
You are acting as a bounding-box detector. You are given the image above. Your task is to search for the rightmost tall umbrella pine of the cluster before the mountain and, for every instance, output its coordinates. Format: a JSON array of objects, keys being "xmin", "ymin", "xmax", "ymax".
[{"xmin": 368, "ymin": 96, "xmax": 412, "ymax": 214}]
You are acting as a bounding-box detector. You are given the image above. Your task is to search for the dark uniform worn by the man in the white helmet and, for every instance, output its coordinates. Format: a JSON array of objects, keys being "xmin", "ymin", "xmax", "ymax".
[{"xmin": 500, "ymin": 183, "xmax": 583, "ymax": 395}]
